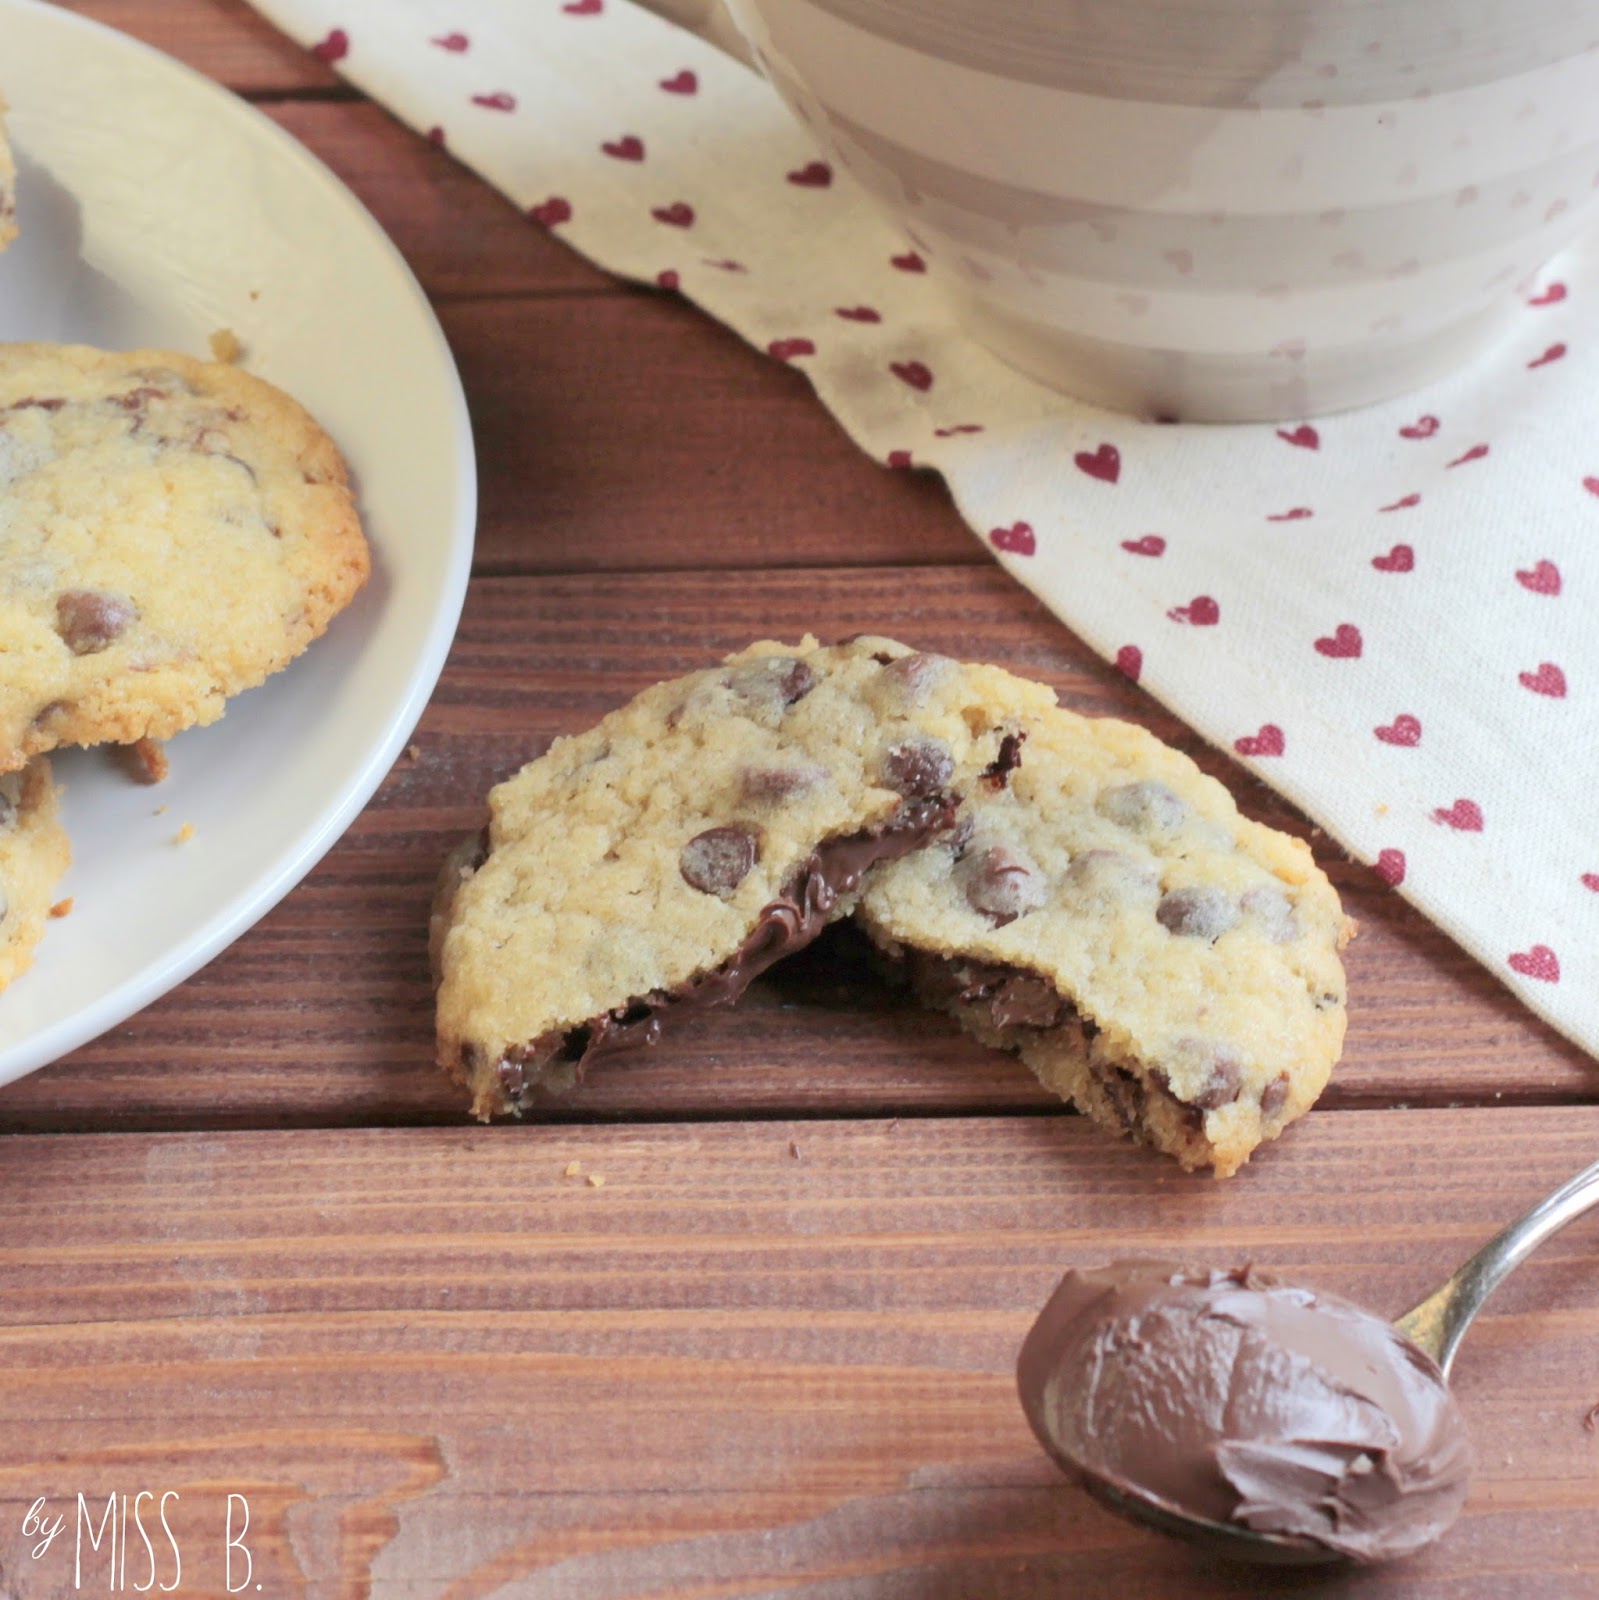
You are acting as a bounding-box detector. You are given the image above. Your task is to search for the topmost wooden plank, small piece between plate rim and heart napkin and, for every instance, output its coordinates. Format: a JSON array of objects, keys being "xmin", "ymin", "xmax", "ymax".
[{"xmin": 61, "ymin": 0, "xmax": 339, "ymax": 94}]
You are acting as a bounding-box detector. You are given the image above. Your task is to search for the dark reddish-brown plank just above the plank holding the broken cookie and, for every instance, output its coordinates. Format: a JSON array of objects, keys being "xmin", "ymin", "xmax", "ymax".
[{"xmin": 442, "ymin": 290, "xmax": 984, "ymax": 573}]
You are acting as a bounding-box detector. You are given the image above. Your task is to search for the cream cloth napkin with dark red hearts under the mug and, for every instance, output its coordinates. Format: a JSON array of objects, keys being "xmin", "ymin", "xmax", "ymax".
[{"xmin": 256, "ymin": 0, "xmax": 1599, "ymax": 1053}]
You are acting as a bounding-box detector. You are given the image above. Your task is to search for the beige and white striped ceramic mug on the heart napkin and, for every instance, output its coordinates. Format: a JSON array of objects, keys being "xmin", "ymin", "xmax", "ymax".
[{"xmin": 697, "ymin": 0, "xmax": 1599, "ymax": 421}]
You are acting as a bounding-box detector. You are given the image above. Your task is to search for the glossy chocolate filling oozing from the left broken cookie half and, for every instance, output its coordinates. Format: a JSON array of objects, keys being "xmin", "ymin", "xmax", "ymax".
[{"xmin": 498, "ymin": 794, "xmax": 960, "ymax": 1101}]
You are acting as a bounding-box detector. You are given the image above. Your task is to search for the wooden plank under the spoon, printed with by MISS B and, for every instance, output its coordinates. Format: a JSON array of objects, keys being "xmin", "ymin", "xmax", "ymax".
[{"xmin": 0, "ymin": 1109, "xmax": 1599, "ymax": 1600}]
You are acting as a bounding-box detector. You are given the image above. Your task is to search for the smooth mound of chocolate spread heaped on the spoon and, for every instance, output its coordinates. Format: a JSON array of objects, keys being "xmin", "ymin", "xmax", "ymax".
[{"xmin": 1016, "ymin": 1261, "xmax": 1471, "ymax": 1562}]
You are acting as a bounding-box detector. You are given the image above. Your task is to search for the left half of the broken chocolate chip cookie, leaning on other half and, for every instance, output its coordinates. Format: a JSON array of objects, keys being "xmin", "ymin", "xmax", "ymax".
[{"xmin": 432, "ymin": 638, "xmax": 1050, "ymax": 1117}]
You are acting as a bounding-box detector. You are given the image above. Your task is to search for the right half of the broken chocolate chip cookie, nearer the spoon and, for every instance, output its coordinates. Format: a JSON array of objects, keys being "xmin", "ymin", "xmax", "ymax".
[{"xmin": 856, "ymin": 681, "xmax": 1353, "ymax": 1176}]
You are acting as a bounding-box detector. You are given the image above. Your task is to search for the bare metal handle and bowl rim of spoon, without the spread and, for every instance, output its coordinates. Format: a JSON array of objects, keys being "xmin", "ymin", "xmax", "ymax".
[{"xmin": 1037, "ymin": 1162, "xmax": 1599, "ymax": 1566}]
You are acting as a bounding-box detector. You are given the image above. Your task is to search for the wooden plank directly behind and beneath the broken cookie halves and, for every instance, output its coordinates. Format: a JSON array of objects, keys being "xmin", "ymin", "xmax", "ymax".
[{"xmin": 0, "ymin": 565, "xmax": 1596, "ymax": 1130}]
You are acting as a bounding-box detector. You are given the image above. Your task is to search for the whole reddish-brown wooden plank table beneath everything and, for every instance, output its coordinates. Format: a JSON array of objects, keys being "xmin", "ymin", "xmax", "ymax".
[{"xmin": 0, "ymin": 0, "xmax": 1599, "ymax": 1600}]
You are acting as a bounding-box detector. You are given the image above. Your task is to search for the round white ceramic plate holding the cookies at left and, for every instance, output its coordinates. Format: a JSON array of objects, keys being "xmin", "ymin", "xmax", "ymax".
[{"xmin": 0, "ymin": 0, "xmax": 477, "ymax": 1083}]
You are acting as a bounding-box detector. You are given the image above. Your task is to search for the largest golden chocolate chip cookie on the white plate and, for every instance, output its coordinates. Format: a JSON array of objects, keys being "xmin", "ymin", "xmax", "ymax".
[{"xmin": 0, "ymin": 344, "xmax": 368, "ymax": 771}]
